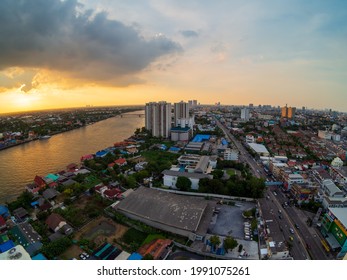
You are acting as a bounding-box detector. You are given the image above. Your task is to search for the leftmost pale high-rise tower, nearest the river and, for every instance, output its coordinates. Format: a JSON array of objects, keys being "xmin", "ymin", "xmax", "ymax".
[{"xmin": 145, "ymin": 101, "xmax": 171, "ymax": 138}]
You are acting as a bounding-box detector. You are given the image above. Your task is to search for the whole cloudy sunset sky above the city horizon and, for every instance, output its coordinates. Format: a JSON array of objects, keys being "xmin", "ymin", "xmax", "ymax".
[{"xmin": 0, "ymin": 0, "xmax": 347, "ymax": 113}]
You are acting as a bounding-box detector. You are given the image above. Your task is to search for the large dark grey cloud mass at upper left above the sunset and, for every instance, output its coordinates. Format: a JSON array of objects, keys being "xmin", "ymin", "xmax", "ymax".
[{"xmin": 0, "ymin": 0, "xmax": 182, "ymax": 88}]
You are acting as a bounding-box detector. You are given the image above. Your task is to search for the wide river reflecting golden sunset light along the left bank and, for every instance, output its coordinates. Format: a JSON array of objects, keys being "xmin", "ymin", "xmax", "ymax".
[{"xmin": 0, "ymin": 111, "xmax": 145, "ymax": 204}]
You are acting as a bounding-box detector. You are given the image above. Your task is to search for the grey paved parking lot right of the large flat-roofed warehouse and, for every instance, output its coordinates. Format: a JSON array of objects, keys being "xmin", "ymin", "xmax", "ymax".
[{"xmin": 208, "ymin": 202, "xmax": 255, "ymax": 239}]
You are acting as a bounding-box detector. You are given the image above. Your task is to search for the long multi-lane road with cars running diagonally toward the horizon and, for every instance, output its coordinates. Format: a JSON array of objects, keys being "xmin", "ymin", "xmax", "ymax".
[{"xmin": 216, "ymin": 119, "xmax": 331, "ymax": 260}]
